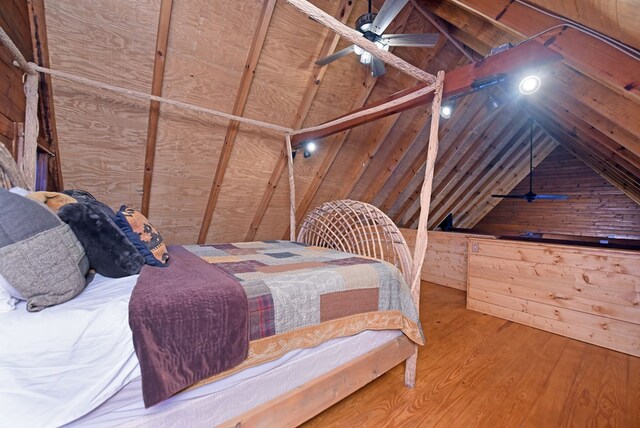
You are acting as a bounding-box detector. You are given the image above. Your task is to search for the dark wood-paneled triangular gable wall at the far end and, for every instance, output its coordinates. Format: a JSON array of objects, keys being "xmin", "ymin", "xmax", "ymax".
[{"xmin": 475, "ymin": 147, "xmax": 640, "ymax": 239}]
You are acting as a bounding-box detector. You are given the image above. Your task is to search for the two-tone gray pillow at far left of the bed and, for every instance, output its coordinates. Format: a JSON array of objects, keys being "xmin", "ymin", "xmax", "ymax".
[{"xmin": 0, "ymin": 189, "xmax": 89, "ymax": 312}]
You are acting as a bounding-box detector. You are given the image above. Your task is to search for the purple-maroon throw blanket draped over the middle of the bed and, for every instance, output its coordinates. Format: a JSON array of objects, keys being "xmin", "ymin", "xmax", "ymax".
[{"xmin": 129, "ymin": 246, "xmax": 249, "ymax": 407}]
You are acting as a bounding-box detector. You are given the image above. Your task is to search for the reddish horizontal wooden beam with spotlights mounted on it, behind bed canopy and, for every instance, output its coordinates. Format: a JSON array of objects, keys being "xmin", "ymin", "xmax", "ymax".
[{"xmin": 292, "ymin": 41, "xmax": 562, "ymax": 146}]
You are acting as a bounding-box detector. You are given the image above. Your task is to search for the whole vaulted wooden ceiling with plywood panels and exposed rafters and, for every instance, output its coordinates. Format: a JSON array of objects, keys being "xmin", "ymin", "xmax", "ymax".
[{"xmin": 40, "ymin": 0, "xmax": 640, "ymax": 243}]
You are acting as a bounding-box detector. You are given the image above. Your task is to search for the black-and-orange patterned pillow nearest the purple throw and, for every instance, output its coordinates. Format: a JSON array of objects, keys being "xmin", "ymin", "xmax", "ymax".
[{"xmin": 114, "ymin": 205, "xmax": 169, "ymax": 266}]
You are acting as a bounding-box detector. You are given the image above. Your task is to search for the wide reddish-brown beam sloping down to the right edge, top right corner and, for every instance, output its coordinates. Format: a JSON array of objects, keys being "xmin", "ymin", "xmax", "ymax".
[{"xmin": 448, "ymin": 0, "xmax": 640, "ymax": 102}]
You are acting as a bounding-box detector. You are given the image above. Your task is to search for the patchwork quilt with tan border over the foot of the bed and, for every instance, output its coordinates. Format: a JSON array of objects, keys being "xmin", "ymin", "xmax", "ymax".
[{"xmin": 184, "ymin": 241, "xmax": 424, "ymax": 386}]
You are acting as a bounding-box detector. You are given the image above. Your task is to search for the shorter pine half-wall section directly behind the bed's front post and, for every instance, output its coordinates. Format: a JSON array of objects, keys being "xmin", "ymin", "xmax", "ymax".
[{"xmin": 400, "ymin": 229, "xmax": 493, "ymax": 290}]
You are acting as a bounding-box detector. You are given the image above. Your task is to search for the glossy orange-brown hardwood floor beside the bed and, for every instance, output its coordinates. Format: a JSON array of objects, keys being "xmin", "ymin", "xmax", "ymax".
[{"xmin": 304, "ymin": 282, "xmax": 640, "ymax": 428}]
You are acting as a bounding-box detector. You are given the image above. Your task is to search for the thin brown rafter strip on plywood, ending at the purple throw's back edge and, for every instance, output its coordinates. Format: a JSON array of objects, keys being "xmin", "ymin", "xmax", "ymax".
[{"xmin": 198, "ymin": 0, "xmax": 276, "ymax": 244}]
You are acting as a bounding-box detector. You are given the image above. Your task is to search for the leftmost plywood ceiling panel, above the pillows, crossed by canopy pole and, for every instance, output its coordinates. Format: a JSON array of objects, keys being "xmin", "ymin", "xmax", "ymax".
[{"xmin": 46, "ymin": 0, "xmax": 160, "ymax": 209}]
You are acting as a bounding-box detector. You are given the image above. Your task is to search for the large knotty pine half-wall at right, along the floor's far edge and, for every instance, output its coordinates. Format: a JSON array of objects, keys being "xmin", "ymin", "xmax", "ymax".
[{"xmin": 467, "ymin": 238, "xmax": 640, "ymax": 356}]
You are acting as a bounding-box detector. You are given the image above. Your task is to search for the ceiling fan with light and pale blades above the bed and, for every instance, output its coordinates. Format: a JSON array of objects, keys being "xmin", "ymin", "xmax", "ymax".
[{"xmin": 316, "ymin": 0, "xmax": 439, "ymax": 77}]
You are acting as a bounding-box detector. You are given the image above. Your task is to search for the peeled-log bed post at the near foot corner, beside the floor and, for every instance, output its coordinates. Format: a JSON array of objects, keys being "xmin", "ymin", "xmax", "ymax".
[{"xmin": 404, "ymin": 71, "xmax": 444, "ymax": 388}]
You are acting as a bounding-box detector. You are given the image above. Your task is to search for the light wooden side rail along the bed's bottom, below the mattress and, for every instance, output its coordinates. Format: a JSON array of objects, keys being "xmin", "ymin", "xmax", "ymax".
[{"xmin": 219, "ymin": 335, "xmax": 414, "ymax": 428}]
